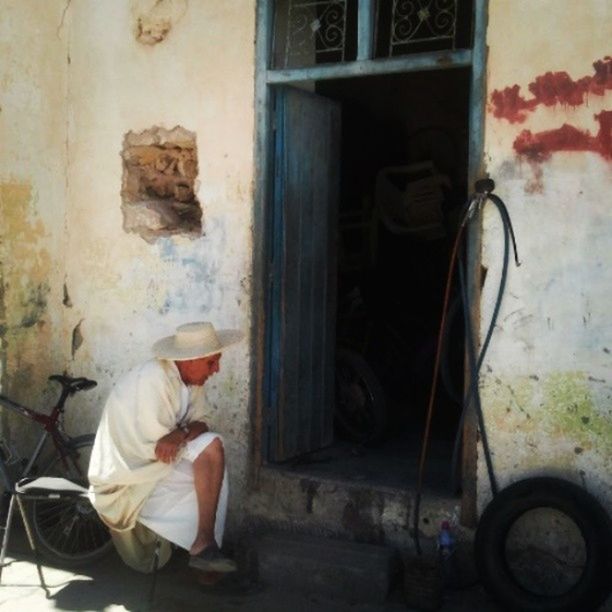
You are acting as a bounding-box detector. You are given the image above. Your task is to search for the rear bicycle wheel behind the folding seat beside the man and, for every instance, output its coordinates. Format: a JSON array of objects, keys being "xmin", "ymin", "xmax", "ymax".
[{"xmin": 29, "ymin": 434, "xmax": 112, "ymax": 566}]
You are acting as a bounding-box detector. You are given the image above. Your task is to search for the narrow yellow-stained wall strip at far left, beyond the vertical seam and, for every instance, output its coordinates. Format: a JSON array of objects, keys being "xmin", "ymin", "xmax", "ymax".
[{"xmin": 0, "ymin": 0, "xmax": 68, "ymax": 450}]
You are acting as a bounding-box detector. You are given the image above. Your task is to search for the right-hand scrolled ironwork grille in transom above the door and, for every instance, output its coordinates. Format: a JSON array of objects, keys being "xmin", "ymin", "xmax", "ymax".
[{"xmin": 389, "ymin": 0, "xmax": 457, "ymax": 56}]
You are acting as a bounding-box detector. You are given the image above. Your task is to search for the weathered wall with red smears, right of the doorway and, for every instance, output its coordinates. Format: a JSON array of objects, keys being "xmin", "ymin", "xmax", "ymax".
[{"xmin": 479, "ymin": 0, "xmax": 612, "ymax": 508}]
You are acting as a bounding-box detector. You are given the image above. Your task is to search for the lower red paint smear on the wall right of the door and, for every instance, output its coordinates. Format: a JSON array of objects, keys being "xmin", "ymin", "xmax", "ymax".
[{"xmin": 514, "ymin": 111, "xmax": 612, "ymax": 162}]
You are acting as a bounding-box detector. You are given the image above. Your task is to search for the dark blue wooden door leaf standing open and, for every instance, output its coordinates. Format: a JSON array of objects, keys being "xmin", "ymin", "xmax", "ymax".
[{"xmin": 266, "ymin": 87, "xmax": 340, "ymax": 461}]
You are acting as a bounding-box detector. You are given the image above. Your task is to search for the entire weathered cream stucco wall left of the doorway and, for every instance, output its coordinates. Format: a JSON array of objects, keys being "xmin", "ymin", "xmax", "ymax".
[{"xmin": 0, "ymin": 0, "xmax": 255, "ymax": 524}]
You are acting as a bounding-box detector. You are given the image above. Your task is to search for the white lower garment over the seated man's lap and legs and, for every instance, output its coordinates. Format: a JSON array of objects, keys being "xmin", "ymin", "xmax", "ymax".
[{"xmin": 138, "ymin": 432, "xmax": 228, "ymax": 550}]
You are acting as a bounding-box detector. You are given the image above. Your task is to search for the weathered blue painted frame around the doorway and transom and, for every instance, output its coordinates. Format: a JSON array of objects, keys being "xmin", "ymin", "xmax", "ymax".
[{"xmin": 252, "ymin": 0, "xmax": 488, "ymax": 522}]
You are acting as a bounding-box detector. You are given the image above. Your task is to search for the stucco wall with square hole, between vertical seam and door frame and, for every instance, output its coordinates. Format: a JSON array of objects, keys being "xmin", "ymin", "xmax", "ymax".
[{"xmin": 66, "ymin": 0, "xmax": 255, "ymax": 516}]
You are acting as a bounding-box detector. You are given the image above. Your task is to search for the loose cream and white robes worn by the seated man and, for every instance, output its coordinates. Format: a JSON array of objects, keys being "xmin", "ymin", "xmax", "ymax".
[{"xmin": 89, "ymin": 359, "xmax": 228, "ymax": 549}]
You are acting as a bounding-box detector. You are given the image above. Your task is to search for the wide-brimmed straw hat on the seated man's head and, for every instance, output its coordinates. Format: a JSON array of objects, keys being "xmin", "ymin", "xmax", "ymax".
[{"xmin": 153, "ymin": 321, "xmax": 244, "ymax": 361}]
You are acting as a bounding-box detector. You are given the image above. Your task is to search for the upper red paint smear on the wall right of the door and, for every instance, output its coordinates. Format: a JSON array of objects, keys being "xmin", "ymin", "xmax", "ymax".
[{"xmin": 491, "ymin": 56, "xmax": 612, "ymax": 123}]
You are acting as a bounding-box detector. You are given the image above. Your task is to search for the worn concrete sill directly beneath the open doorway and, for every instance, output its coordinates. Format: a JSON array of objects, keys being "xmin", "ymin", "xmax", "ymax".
[{"xmin": 240, "ymin": 468, "xmax": 464, "ymax": 552}]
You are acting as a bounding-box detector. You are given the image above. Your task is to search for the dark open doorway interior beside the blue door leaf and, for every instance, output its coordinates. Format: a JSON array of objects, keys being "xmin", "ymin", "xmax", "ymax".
[{"xmin": 266, "ymin": 69, "xmax": 471, "ymax": 489}]
